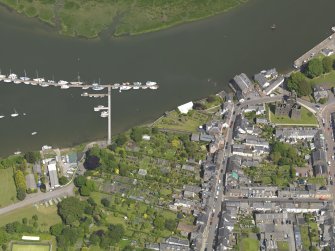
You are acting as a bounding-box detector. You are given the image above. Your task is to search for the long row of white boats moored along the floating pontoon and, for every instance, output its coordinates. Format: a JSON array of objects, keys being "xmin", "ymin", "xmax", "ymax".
[{"xmin": 0, "ymin": 73, "xmax": 158, "ymax": 91}]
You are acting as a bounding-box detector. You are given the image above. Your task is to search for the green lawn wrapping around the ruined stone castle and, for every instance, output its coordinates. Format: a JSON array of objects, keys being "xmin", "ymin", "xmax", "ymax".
[{"xmin": 268, "ymin": 106, "xmax": 318, "ymax": 126}]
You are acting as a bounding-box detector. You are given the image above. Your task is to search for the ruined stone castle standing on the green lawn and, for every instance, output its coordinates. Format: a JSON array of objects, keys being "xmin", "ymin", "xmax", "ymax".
[{"xmin": 275, "ymin": 92, "xmax": 301, "ymax": 119}]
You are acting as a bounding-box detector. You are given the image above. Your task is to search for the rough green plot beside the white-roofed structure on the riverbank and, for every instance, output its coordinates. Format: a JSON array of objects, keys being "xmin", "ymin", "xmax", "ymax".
[{"xmin": 154, "ymin": 110, "xmax": 209, "ymax": 132}]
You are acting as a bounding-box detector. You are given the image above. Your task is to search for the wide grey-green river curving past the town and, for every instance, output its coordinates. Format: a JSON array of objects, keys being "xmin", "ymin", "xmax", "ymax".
[{"xmin": 0, "ymin": 0, "xmax": 335, "ymax": 156}]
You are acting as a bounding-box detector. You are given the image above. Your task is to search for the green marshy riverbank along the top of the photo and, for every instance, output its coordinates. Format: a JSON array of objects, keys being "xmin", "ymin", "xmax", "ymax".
[{"xmin": 0, "ymin": 0, "xmax": 247, "ymax": 38}]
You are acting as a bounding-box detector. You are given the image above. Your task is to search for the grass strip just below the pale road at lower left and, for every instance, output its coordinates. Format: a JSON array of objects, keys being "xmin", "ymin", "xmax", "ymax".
[{"xmin": 0, "ymin": 206, "xmax": 61, "ymax": 231}]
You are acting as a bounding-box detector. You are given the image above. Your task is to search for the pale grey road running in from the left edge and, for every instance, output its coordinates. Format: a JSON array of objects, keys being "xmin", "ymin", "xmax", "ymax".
[{"xmin": 0, "ymin": 183, "xmax": 74, "ymax": 215}]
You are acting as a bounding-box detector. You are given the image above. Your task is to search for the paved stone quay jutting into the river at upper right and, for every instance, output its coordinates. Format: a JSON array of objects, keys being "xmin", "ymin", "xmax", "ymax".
[{"xmin": 293, "ymin": 30, "xmax": 335, "ymax": 69}]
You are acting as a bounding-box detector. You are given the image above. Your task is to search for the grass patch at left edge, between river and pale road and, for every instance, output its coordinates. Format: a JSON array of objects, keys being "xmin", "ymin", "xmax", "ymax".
[{"xmin": 0, "ymin": 168, "xmax": 16, "ymax": 207}]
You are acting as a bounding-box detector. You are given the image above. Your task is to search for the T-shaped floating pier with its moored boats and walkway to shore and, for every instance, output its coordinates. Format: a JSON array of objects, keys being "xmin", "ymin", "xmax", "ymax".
[{"xmin": 0, "ymin": 73, "xmax": 159, "ymax": 145}]
